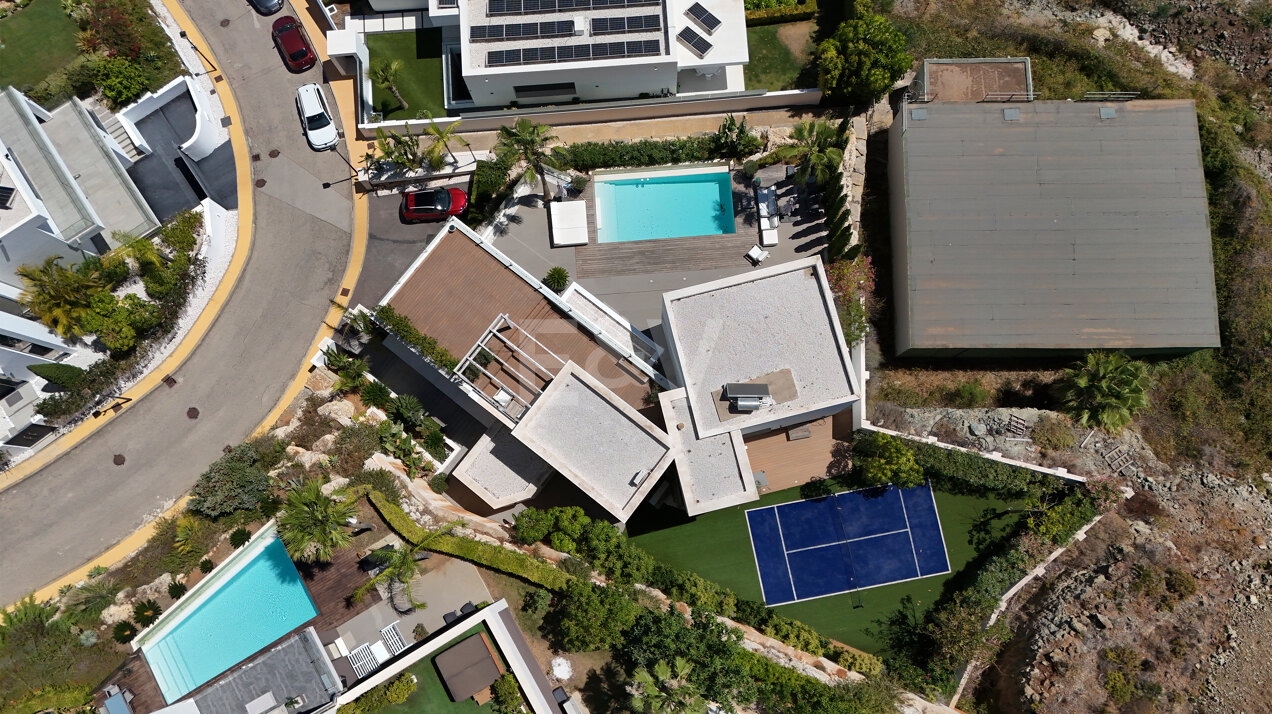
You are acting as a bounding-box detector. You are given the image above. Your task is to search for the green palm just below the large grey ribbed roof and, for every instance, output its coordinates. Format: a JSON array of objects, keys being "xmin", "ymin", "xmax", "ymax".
[{"xmin": 1058, "ymin": 353, "xmax": 1149, "ymax": 434}]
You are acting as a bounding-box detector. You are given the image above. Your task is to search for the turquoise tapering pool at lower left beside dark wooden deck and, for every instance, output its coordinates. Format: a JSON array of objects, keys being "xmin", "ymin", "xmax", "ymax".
[{"xmin": 141, "ymin": 538, "xmax": 318, "ymax": 704}]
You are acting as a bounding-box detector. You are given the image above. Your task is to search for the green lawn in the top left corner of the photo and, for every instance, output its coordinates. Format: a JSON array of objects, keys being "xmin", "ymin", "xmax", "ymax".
[{"xmin": 0, "ymin": 0, "xmax": 79, "ymax": 89}]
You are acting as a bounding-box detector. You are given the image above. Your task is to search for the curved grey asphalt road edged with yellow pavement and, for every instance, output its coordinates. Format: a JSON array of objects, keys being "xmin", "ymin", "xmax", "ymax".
[{"xmin": 0, "ymin": 0, "xmax": 352, "ymax": 603}]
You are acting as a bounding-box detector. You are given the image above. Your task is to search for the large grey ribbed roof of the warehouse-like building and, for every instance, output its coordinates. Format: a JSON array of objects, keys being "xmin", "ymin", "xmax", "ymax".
[{"xmin": 893, "ymin": 99, "xmax": 1219, "ymax": 351}]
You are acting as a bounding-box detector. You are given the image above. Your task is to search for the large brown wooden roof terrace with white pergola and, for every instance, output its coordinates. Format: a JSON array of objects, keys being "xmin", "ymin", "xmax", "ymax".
[{"xmin": 389, "ymin": 233, "xmax": 649, "ymax": 407}]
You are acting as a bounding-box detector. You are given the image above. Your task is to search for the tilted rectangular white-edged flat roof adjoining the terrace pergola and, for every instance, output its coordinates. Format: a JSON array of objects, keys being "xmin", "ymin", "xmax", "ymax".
[{"xmin": 513, "ymin": 363, "xmax": 673, "ymax": 521}]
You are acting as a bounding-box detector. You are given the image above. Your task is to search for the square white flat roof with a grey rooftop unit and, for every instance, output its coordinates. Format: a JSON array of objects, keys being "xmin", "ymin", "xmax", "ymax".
[{"xmin": 663, "ymin": 257, "xmax": 859, "ymax": 439}]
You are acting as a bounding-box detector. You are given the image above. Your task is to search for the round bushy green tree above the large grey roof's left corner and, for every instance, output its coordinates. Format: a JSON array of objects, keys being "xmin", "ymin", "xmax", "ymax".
[{"xmin": 817, "ymin": 11, "xmax": 915, "ymax": 107}]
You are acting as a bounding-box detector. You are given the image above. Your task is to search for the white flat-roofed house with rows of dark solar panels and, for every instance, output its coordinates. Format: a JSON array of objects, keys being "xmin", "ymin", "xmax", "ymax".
[{"xmin": 459, "ymin": 0, "xmax": 749, "ymax": 106}]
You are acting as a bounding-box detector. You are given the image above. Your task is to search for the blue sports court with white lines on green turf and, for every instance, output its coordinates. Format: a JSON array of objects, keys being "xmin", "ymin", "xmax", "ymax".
[{"xmin": 747, "ymin": 484, "xmax": 950, "ymax": 605}]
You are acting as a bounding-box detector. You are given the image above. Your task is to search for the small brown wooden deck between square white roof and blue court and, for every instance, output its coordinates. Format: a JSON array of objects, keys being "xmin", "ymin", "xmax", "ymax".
[{"xmin": 745, "ymin": 416, "xmax": 847, "ymax": 494}]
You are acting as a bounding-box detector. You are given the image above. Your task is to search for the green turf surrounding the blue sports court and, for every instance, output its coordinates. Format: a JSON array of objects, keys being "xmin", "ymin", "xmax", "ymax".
[{"xmin": 628, "ymin": 489, "xmax": 1007, "ymax": 652}]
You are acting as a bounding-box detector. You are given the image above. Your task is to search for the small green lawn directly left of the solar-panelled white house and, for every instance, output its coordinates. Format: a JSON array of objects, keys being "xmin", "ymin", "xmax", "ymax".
[{"xmin": 366, "ymin": 29, "xmax": 446, "ymax": 120}]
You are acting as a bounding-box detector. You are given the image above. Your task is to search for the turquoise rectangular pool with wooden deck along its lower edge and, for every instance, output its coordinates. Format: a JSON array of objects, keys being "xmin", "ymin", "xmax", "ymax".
[{"xmin": 597, "ymin": 172, "xmax": 736, "ymax": 243}]
